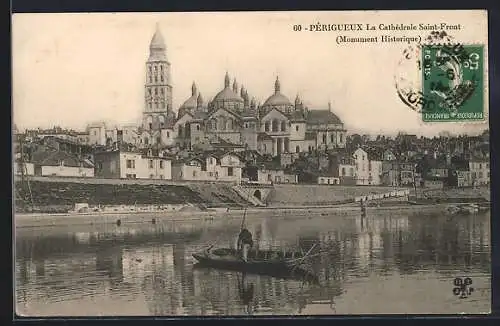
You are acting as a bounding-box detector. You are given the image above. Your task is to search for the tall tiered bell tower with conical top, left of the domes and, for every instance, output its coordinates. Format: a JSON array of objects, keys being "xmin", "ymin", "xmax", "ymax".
[{"xmin": 142, "ymin": 24, "xmax": 175, "ymax": 130}]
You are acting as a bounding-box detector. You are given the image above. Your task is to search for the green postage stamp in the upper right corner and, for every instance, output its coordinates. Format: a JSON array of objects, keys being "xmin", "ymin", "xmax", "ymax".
[{"xmin": 421, "ymin": 44, "xmax": 485, "ymax": 122}]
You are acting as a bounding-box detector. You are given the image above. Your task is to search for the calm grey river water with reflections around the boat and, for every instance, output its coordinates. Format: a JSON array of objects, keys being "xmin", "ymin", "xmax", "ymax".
[{"xmin": 15, "ymin": 212, "xmax": 491, "ymax": 316}]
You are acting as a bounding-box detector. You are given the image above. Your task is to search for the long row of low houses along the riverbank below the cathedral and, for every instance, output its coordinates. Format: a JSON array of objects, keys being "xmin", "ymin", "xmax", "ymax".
[{"xmin": 14, "ymin": 128, "xmax": 490, "ymax": 187}]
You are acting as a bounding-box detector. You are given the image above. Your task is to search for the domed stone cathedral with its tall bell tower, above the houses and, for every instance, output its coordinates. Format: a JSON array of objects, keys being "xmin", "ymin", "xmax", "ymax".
[{"xmin": 90, "ymin": 26, "xmax": 346, "ymax": 156}]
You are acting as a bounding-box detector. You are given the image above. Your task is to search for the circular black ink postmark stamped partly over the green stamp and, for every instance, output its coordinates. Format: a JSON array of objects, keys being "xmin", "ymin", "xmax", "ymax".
[{"xmin": 394, "ymin": 31, "xmax": 482, "ymax": 119}]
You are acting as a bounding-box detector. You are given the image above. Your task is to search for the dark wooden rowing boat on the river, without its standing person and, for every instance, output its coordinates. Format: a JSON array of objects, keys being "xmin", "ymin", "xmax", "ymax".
[{"xmin": 193, "ymin": 247, "xmax": 313, "ymax": 278}]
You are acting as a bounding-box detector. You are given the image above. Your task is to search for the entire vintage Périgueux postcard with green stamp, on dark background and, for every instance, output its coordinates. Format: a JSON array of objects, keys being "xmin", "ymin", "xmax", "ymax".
[{"xmin": 12, "ymin": 10, "xmax": 491, "ymax": 317}]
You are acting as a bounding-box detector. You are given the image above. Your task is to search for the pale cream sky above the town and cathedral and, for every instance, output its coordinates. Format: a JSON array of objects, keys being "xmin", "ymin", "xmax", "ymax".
[{"xmin": 12, "ymin": 11, "xmax": 487, "ymax": 135}]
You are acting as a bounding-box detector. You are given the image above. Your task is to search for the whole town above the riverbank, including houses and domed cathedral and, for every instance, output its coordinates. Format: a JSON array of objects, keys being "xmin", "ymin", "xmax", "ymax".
[{"xmin": 13, "ymin": 27, "xmax": 490, "ymax": 188}]
